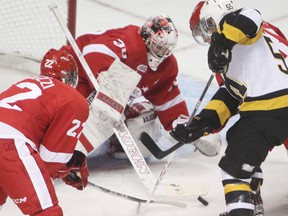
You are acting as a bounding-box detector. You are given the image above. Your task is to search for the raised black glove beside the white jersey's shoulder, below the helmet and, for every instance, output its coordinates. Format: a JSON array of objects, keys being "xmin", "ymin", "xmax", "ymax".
[{"xmin": 208, "ymin": 32, "xmax": 232, "ymax": 73}]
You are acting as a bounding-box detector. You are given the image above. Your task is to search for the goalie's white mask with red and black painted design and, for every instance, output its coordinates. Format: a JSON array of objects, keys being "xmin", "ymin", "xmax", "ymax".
[{"xmin": 139, "ymin": 14, "xmax": 178, "ymax": 71}]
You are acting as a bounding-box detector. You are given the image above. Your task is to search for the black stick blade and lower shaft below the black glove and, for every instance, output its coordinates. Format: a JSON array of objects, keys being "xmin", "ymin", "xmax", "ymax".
[{"xmin": 140, "ymin": 132, "xmax": 185, "ymax": 159}]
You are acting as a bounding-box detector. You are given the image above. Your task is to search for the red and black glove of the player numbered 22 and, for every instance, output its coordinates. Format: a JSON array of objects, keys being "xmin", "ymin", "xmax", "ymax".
[{"xmin": 62, "ymin": 150, "xmax": 89, "ymax": 190}]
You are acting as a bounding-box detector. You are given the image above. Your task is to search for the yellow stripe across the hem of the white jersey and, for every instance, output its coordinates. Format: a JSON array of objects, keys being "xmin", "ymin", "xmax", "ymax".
[{"xmin": 240, "ymin": 95, "xmax": 288, "ymax": 112}]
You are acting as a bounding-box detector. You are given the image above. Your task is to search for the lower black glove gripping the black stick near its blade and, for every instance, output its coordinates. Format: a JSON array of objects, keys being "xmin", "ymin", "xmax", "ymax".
[{"xmin": 170, "ymin": 116, "xmax": 212, "ymax": 143}]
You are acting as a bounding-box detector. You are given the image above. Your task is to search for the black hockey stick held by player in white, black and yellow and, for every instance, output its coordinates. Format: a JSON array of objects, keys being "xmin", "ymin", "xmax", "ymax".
[{"xmin": 140, "ymin": 73, "xmax": 214, "ymax": 159}]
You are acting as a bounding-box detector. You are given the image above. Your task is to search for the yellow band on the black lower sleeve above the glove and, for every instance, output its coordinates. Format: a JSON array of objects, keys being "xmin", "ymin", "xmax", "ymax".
[{"xmin": 204, "ymin": 100, "xmax": 231, "ymax": 126}]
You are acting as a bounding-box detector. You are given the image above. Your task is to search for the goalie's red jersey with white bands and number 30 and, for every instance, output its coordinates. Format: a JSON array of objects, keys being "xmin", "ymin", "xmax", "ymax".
[{"xmin": 62, "ymin": 25, "xmax": 188, "ymax": 130}]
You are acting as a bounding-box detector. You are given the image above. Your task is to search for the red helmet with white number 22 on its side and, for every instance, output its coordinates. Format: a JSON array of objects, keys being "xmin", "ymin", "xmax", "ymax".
[{"xmin": 40, "ymin": 49, "xmax": 78, "ymax": 88}]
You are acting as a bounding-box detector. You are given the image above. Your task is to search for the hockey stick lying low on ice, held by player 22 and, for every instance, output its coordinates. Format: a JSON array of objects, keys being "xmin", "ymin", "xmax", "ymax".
[{"xmin": 88, "ymin": 181, "xmax": 187, "ymax": 208}]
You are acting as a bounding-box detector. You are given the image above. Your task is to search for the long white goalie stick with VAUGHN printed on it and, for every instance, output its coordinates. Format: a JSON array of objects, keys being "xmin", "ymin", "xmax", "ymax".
[{"xmin": 49, "ymin": 4, "xmax": 208, "ymax": 199}]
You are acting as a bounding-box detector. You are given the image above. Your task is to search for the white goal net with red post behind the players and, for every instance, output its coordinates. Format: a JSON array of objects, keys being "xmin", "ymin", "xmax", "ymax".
[{"xmin": 0, "ymin": 0, "xmax": 76, "ymax": 74}]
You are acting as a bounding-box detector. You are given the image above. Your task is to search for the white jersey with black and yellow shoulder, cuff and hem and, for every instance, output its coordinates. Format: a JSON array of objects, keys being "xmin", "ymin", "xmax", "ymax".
[{"xmin": 200, "ymin": 8, "xmax": 288, "ymax": 128}]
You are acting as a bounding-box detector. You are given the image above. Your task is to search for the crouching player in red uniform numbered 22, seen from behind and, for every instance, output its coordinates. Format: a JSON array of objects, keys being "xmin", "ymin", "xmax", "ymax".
[{"xmin": 0, "ymin": 49, "xmax": 89, "ymax": 216}]
